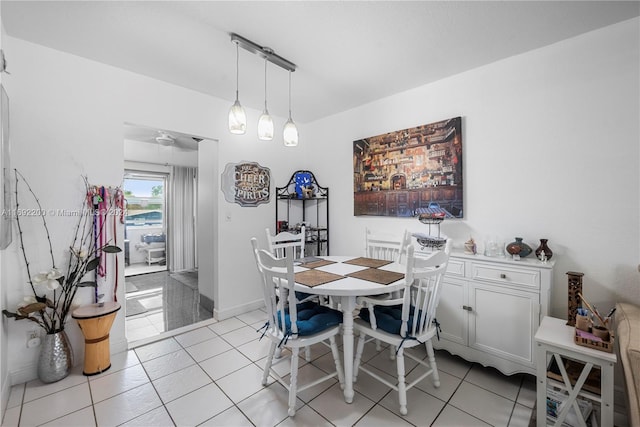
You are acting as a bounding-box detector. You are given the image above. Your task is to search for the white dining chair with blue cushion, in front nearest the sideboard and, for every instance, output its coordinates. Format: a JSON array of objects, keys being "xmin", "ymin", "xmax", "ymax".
[{"xmin": 353, "ymin": 246, "xmax": 449, "ymax": 415}]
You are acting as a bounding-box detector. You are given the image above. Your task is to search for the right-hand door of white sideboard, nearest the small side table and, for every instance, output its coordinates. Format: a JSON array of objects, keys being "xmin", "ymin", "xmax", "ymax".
[{"xmin": 469, "ymin": 282, "xmax": 540, "ymax": 367}]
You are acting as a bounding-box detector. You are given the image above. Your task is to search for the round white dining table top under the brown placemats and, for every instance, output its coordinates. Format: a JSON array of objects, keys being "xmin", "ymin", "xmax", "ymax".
[{"xmin": 294, "ymin": 255, "xmax": 406, "ymax": 296}]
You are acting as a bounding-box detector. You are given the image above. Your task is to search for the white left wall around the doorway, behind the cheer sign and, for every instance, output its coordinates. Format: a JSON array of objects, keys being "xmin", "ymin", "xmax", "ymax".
[{"xmin": 1, "ymin": 37, "xmax": 304, "ymax": 384}]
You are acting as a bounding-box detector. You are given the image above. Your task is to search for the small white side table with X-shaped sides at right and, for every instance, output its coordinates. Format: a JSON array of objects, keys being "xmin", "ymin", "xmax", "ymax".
[{"xmin": 535, "ymin": 317, "xmax": 616, "ymax": 427}]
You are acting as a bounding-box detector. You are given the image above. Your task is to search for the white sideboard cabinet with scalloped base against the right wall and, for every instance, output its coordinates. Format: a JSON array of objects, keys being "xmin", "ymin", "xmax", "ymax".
[{"xmin": 433, "ymin": 252, "xmax": 554, "ymax": 375}]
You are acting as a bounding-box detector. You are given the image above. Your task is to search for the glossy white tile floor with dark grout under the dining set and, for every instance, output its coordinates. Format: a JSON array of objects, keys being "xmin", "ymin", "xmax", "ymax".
[{"xmin": 2, "ymin": 310, "xmax": 535, "ymax": 427}]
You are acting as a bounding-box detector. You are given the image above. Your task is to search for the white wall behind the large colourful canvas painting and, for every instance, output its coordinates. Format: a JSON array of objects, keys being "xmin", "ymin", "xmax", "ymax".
[{"xmin": 305, "ymin": 18, "xmax": 640, "ymax": 318}]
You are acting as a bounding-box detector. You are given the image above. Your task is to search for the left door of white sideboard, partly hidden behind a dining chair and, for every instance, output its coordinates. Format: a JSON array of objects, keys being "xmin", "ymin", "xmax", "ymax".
[{"xmin": 436, "ymin": 277, "xmax": 468, "ymax": 345}]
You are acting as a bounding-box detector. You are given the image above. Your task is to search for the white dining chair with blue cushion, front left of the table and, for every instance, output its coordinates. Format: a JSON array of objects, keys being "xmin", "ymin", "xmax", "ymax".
[{"xmin": 252, "ymin": 242, "xmax": 344, "ymax": 417}]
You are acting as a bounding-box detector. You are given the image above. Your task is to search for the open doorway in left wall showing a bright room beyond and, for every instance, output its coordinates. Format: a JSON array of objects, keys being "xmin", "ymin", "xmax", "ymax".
[{"xmin": 123, "ymin": 124, "xmax": 213, "ymax": 343}]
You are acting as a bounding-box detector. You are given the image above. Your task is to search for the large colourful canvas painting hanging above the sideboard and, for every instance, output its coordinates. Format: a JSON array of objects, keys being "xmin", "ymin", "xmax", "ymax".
[{"xmin": 353, "ymin": 117, "xmax": 464, "ymax": 218}]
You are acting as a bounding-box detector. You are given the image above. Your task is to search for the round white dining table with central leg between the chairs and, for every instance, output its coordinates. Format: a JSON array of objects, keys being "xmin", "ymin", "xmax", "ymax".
[{"xmin": 294, "ymin": 256, "xmax": 406, "ymax": 403}]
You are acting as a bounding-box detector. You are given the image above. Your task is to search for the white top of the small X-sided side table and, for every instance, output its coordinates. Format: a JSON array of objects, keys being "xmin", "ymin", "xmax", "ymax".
[{"xmin": 535, "ymin": 316, "xmax": 617, "ymax": 363}]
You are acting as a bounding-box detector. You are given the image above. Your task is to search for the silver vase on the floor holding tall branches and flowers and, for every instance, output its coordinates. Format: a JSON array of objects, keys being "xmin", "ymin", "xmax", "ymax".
[{"xmin": 38, "ymin": 330, "xmax": 73, "ymax": 383}]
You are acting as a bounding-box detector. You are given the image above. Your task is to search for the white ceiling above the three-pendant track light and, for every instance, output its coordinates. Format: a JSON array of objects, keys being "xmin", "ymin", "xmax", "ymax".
[{"xmin": 1, "ymin": 0, "xmax": 640, "ymax": 123}]
